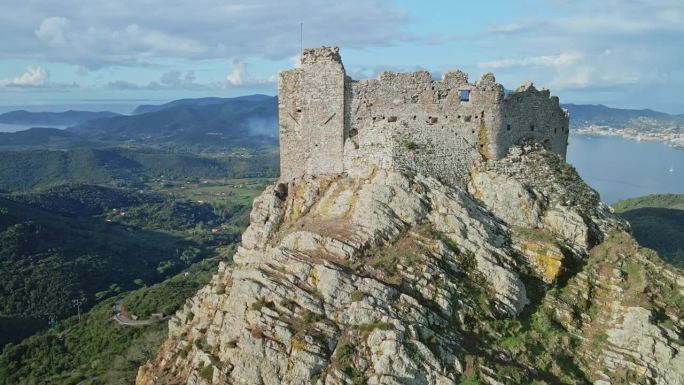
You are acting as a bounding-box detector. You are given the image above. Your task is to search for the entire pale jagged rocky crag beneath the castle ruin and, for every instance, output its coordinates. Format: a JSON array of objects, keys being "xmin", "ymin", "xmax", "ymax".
[{"xmin": 136, "ymin": 148, "xmax": 684, "ymax": 385}]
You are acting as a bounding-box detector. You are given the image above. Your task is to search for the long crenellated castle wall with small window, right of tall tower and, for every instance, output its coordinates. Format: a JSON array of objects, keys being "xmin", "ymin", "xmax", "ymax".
[{"xmin": 345, "ymin": 71, "xmax": 503, "ymax": 184}]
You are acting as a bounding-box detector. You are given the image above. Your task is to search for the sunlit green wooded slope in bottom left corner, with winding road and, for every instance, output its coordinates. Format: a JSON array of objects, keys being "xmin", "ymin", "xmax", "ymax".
[{"xmin": 0, "ymin": 256, "xmax": 219, "ymax": 385}]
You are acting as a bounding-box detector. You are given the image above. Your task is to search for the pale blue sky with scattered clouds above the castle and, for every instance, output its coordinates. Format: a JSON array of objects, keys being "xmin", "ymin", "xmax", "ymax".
[{"xmin": 0, "ymin": 0, "xmax": 684, "ymax": 113}]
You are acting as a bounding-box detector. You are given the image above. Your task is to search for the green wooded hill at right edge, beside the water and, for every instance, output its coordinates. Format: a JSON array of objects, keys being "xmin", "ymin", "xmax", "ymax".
[{"xmin": 614, "ymin": 194, "xmax": 684, "ymax": 268}]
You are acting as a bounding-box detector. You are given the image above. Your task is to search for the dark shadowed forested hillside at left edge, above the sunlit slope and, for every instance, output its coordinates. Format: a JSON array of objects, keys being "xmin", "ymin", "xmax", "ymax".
[{"xmin": 0, "ymin": 198, "xmax": 190, "ymax": 343}]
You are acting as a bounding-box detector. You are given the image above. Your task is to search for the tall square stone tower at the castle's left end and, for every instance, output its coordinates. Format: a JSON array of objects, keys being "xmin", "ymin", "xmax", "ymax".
[{"xmin": 278, "ymin": 50, "xmax": 346, "ymax": 179}]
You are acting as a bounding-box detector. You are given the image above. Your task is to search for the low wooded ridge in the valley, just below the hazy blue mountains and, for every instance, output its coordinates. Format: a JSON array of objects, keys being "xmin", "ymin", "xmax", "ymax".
[{"xmin": 0, "ymin": 147, "xmax": 278, "ymax": 191}]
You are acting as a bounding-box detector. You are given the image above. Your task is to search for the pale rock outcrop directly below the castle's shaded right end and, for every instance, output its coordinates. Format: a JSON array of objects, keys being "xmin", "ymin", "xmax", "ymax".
[{"xmin": 468, "ymin": 145, "xmax": 629, "ymax": 252}]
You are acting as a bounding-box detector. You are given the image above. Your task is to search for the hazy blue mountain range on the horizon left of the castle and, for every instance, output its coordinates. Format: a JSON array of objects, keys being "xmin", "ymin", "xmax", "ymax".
[{"xmin": 0, "ymin": 95, "xmax": 278, "ymax": 148}]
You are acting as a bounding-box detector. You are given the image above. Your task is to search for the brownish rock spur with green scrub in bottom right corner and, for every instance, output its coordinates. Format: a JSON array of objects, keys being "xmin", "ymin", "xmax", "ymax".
[{"xmin": 544, "ymin": 233, "xmax": 684, "ymax": 385}]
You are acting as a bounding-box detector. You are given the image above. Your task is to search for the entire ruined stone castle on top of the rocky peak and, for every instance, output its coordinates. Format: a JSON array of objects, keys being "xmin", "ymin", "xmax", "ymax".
[{"xmin": 278, "ymin": 47, "xmax": 569, "ymax": 186}]
